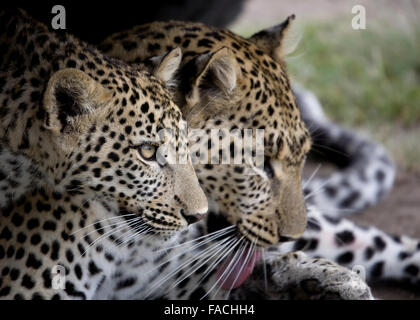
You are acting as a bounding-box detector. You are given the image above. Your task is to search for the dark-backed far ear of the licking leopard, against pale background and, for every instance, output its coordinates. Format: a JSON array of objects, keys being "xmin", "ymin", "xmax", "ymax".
[{"xmin": 248, "ymin": 14, "xmax": 295, "ymax": 61}]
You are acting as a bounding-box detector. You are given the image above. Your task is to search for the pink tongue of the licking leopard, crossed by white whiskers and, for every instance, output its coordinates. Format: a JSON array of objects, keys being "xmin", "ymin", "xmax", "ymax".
[{"xmin": 216, "ymin": 250, "xmax": 261, "ymax": 290}]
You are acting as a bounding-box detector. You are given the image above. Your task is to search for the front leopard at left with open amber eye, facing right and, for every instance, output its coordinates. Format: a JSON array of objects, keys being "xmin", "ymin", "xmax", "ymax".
[{"xmin": 0, "ymin": 9, "xmax": 208, "ymax": 299}]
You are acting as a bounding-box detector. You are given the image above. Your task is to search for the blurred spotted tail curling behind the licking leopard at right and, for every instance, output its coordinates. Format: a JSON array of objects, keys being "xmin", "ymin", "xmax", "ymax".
[{"xmin": 293, "ymin": 86, "xmax": 396, "ymax": 217}]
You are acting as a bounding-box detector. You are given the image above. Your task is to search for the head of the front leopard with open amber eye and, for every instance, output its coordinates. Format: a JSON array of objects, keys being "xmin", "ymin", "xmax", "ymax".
[{"xmin": 32, "ymin": 57, "xmax": 207, "ymax": 236}]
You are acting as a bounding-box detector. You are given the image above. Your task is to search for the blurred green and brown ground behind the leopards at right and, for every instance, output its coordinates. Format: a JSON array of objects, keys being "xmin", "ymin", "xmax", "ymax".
[{"xmin": 229, "ymin": 0, "xmax": 420, "ymax": 299}]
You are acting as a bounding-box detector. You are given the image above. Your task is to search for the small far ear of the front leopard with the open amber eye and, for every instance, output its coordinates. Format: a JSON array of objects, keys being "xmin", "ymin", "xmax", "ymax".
[{"xmin": 145, "ymin": 47, "xmax": 182, "ymax": 83}]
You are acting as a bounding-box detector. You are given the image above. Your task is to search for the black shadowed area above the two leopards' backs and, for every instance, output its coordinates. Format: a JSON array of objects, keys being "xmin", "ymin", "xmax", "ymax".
[{"xmin": 7, "ymin": 0, "xmax": 246, "ymax": 43}]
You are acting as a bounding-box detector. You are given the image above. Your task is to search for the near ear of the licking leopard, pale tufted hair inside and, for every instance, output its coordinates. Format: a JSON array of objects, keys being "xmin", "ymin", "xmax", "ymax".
[{"xmin": 183, "ymin": 47, "xmax": 239, "ymax": 107}]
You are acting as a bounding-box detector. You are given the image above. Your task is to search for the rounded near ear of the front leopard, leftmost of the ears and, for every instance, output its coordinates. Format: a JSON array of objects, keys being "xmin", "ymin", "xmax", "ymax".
[{"xmin": 43, "ymin": 68, "xmax": 111, "ymax": 133}]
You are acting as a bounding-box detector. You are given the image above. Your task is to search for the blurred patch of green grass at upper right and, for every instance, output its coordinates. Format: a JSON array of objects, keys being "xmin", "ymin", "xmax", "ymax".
[{"xmin": 286, "ymin": 19, "xmax": 420, "ymax": 128}]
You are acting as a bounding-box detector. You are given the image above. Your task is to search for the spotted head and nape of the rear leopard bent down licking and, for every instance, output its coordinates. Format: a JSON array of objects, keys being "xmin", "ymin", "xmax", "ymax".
[{"xmin": 100, "ymin": 18, "xmax": 311, "ymax": 247}]
